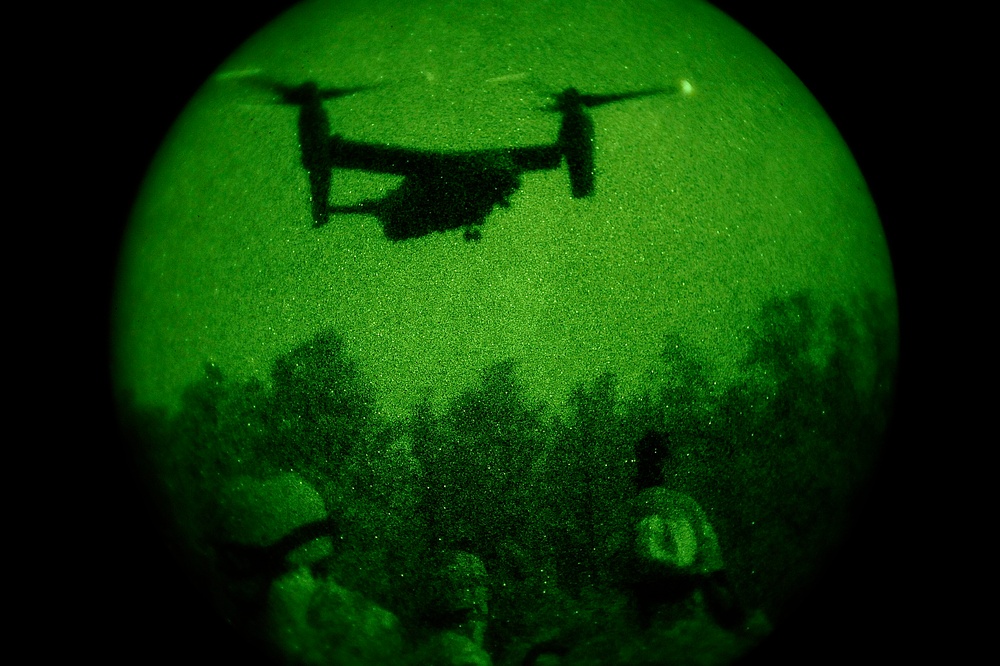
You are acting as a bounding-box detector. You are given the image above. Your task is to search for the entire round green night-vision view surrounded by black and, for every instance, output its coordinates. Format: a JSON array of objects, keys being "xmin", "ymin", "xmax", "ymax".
[{"xmin": 114, "ymin": 0, "xmax": 897, "ymax": 666}]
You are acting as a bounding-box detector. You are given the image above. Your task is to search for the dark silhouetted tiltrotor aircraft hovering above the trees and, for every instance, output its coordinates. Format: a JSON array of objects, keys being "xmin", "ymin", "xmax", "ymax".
[{"xmin": 268, "ymin": 81, "xmax": 672, "ymax": 241}]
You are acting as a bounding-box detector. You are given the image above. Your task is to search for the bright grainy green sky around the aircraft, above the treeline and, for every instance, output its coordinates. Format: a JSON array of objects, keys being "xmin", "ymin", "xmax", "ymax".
[{"xmin": 116, "ymin": 0, "xmax": 893, "ymax": 416}]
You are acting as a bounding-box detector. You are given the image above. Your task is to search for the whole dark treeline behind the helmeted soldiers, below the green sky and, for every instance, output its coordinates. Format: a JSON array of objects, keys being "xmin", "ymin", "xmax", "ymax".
[{"xmin": 125, "ymin": 294, "xmax": 896, "ymax": 658}]
